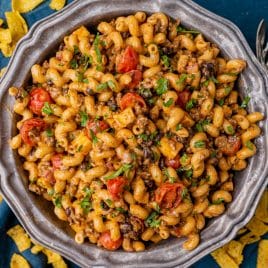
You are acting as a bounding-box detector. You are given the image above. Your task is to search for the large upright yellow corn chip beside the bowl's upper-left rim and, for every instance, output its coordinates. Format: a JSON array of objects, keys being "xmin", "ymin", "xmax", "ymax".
[{"xmin": 5, "ymin": 11, "xmax": 28, "ymax": 44}]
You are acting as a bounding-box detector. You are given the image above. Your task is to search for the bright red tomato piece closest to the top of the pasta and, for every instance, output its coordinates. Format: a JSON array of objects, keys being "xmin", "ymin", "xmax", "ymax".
[{"xmin": 116, "ymin": 46, "xmax": 139, "ymax": 73}]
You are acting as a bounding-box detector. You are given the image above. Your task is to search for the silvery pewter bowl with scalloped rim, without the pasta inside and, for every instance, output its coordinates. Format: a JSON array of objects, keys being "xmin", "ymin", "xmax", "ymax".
[{"xmin": 0, "ymin": 0, "xmax": 268, "ymax": 268}]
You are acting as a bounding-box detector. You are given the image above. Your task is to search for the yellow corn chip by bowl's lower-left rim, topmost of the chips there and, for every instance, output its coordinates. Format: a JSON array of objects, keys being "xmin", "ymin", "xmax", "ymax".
[{"xmin": 7, "ymin": 225, "xmax": 31, "ymax": 252}]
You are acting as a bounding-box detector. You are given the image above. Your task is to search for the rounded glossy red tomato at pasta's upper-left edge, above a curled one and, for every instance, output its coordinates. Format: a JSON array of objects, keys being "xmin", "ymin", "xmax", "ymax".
[{"xmin": 29, "ymin": 88, "xmax": 52, "ymax": 115}]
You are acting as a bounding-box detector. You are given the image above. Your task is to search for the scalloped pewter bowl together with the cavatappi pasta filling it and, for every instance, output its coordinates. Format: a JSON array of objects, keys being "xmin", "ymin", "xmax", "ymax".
[{"xmin": 0, "ymin": 1, "xmax": 268, "ymax": 267}]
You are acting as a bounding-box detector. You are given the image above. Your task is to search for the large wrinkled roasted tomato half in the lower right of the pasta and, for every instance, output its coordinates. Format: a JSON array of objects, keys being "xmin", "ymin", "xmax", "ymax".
[{"xmin": 155, "ymin": 182, "xmax": 184, "ymax": 209}]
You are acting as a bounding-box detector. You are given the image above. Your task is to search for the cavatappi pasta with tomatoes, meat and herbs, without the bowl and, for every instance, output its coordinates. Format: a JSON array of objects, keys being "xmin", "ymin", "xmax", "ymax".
[{"xmin": 9, "ymin": 12, "xmax": 263, "ymax": 252}]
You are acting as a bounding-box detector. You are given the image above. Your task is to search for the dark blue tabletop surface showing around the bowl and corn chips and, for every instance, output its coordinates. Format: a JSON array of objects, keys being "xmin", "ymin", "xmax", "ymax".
[{"xmin": 0, "ymin": 0, "xmax": 268, "ymax": 268}]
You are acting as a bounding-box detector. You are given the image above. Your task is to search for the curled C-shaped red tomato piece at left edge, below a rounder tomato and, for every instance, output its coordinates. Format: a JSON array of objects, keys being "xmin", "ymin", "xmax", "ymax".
[{"xmin": 20, "ymin": 118, "xmax": 46, "ymax": 146}]
